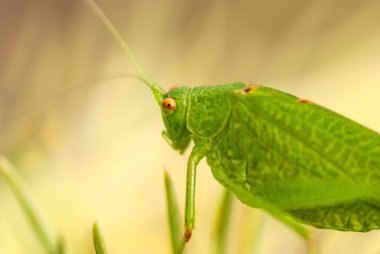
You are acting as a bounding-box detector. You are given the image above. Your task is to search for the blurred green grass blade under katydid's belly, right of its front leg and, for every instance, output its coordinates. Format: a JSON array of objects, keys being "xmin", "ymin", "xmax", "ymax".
[{"xmin": 214, "ymin": 189, "xmax": 233, "ymax": 254}]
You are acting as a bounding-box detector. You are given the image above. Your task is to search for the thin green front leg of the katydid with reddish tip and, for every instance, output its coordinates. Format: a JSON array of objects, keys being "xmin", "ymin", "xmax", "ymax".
[{"xmin": 184, "ymin": 146, "xmax": 209, "ymax": 242}]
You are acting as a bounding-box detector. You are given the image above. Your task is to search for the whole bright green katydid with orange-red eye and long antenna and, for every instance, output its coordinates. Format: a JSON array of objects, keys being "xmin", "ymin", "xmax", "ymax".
[{"xmin": 87, "ymin": 0, "xmax": 380, "ymax": 247}]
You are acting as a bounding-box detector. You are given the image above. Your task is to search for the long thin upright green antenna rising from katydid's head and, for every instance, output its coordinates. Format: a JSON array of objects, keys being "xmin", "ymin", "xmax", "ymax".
[{"xmin": 86, "ymin": 0, "xmax": 164, "ymax": 104}]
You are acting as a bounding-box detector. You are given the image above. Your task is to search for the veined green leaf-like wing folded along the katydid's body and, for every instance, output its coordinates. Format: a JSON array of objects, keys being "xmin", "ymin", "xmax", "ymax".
[{"xmin": 208, "ymin": 87, "xmax": 380, "ymax": 231}]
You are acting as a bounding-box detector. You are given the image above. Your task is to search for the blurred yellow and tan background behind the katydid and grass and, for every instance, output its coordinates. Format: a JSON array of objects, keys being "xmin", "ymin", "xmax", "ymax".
[{"xmin": 0, "ymin": 0, "xmax": 380, "ymax": 253}]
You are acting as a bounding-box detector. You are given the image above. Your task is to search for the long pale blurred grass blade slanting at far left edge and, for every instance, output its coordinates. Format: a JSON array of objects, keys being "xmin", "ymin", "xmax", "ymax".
[{"xmin": 0, "ymin": 157, "xmax": 57, "ymax": 253}]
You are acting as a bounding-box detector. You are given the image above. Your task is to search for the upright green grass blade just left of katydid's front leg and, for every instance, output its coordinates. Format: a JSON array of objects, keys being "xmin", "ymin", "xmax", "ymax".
[{"xmin": 165, "ymin": 171, "xmax": 185, "ymax": 254}]
